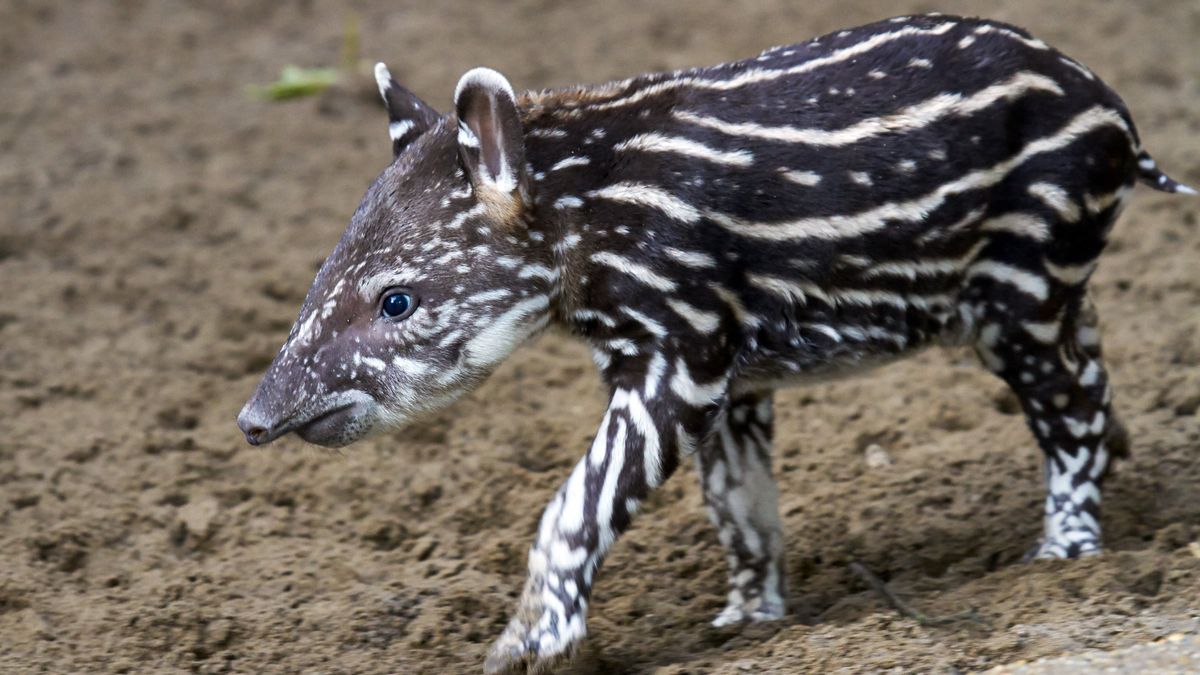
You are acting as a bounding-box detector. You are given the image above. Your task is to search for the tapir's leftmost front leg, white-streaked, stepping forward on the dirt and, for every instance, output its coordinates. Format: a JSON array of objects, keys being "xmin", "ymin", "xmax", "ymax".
[{"xmin": 484, "ymin": 348, "xmax": 726, "ymax": 673}]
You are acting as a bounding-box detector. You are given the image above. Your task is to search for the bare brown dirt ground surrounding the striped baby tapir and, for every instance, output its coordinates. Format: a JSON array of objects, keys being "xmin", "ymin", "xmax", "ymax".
[{"xmin": 0, "ymin": 0, "xmax": 1200, "ymax": 675}]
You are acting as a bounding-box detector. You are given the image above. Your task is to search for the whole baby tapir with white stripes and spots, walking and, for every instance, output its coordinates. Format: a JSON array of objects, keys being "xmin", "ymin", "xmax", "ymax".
[{"xmin": 238, "ymin": 16, "xmax": 1193, "ymax": 671}]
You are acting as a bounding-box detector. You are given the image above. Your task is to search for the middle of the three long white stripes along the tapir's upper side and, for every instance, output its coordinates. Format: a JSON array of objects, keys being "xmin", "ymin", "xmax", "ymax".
[{"xmin": 674, "ymin": 72, "xmax": 1063, "ymax": 147}]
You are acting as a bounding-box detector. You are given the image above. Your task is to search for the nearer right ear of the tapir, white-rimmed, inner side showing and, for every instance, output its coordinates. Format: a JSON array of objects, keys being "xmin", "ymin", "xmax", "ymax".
[{"xmin": 454, "ymin": 68, "xmax": 524, "ymax": 197}]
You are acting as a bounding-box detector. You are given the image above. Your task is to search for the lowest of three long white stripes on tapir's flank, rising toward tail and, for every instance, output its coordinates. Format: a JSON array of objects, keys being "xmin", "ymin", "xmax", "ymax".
[{"xmin": 704, "ymin": 106, "xmax": 1129, "ymax": 241}]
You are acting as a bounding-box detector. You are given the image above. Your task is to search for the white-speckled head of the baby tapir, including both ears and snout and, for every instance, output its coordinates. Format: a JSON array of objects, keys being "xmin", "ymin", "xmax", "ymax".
[{"xmin": 238, "ymin": 64, "xmax": 556, "ymax": 447}]
